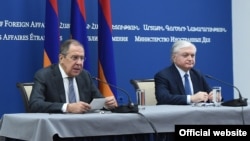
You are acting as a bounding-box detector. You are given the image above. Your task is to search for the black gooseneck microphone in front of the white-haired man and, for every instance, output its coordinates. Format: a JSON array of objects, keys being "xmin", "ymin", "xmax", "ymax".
[{"xmin": 205, "ymin": 75, "xmax": 247, "ymax": 107}]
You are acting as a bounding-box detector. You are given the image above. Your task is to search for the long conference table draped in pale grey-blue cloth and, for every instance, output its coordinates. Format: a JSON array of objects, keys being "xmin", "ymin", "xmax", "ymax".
[{"xmin": 0, "ymin": 105, "xmax": 250, "ymax": 141}]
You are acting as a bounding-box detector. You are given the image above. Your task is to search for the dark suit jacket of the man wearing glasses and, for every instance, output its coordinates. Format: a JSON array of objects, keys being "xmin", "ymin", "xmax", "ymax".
[{"xmin": 29, "ymin": 64, "xmax": 103, "ymax": 113}]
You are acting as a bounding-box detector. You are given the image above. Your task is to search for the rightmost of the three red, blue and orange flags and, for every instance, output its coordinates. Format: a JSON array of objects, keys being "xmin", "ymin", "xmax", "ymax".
[{"xmin": 98, "ymin": 0, "xmax": 117, "ymax": 98}]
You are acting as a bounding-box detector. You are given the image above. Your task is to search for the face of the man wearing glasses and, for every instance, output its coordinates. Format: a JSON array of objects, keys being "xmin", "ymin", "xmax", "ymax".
[{"xmin": 59, "ymin": 44, "xmax": 85, "ymax": 77}]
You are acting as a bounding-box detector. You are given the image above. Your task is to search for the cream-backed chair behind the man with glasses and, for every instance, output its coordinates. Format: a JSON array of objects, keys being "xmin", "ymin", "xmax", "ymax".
[{"xmin": 16, "ymin": 82, "xmax": 34, "ymax": 113}]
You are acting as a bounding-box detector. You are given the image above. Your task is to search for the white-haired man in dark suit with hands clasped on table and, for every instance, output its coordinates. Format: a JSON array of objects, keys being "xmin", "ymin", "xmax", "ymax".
[{"xmin": 154, "ymin": 40, "xmax": 213, "ymax": 105}]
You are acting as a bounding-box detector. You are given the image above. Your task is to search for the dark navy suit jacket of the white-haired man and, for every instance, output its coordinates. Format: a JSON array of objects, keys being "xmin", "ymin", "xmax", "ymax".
[{"xmin": 154, "ymin": 64, "xmax": 212, "ymax": 105}]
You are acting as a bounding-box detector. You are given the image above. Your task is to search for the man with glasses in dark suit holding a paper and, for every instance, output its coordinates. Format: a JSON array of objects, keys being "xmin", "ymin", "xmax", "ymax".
[{"xmin": 29, "ymin": 39, "xmax": 117, "ymax": 113}]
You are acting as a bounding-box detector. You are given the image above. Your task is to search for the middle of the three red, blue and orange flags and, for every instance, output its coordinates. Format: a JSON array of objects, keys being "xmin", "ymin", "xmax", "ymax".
[{"xmin": 70, "ymin": 0, "xmax": 90, "ymax": 70}]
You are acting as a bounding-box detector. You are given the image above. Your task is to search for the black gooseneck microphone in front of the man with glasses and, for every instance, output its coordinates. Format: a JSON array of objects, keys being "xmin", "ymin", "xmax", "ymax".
[{"xmin": 92, "ymin": 77, "xmax": 138, "ymax": 113}]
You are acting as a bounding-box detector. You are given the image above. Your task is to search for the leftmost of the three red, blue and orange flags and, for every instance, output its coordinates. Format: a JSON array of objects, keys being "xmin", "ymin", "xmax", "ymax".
[{"xmin": 43, "ymin": 0, "xmax": 60, "ymax": 67}]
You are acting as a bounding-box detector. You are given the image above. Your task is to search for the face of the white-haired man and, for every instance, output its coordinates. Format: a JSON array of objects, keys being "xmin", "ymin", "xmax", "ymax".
[{"xmin": 172, "ymin": 47, "xmax": 196, "ymax": 71}]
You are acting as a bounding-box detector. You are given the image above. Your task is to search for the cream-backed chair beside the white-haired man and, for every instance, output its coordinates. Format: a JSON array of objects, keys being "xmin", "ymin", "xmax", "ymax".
[{"xmin": 130, "ymin": 79, "xmax": 157, "ymax": 105}]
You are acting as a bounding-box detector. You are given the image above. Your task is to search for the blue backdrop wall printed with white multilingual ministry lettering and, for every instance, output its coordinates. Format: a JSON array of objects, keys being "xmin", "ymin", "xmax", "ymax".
[{"xmin": 0, "ymin": 0, "xmax": 233, "ymax": 116}]
